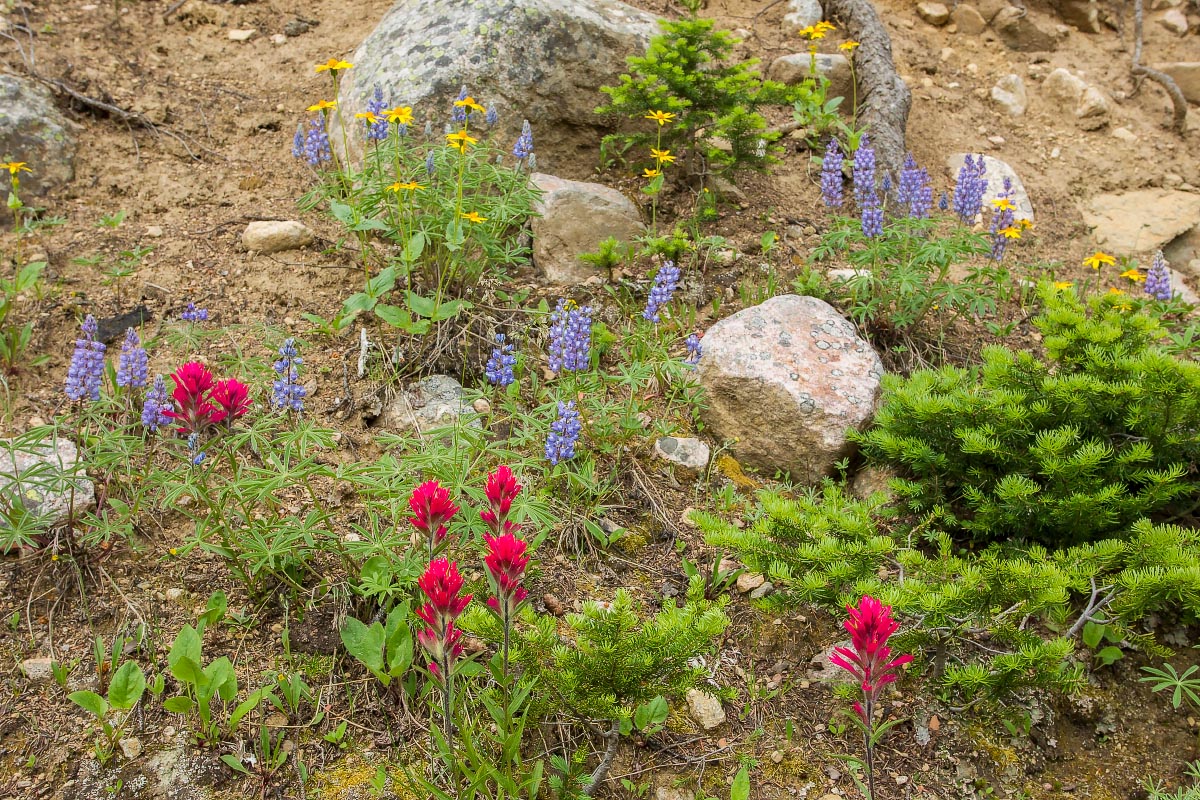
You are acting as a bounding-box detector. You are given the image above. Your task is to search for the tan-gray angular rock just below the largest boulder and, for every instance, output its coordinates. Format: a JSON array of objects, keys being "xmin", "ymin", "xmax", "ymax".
[{"xmin": 529, "ymin": 173, "xmax": 646, "ymax": 285}]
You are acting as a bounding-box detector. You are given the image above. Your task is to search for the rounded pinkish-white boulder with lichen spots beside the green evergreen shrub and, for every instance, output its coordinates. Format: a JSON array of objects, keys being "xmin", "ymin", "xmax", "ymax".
[{"xmin": 697, "ymin": 295, "xmax": 883, "ymax": 483}]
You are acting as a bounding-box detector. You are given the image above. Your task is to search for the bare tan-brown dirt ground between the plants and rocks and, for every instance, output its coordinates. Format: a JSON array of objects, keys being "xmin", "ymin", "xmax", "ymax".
[{"xmin": 0, "ymin": 0, "xmax": 1200, "ymax": 799}]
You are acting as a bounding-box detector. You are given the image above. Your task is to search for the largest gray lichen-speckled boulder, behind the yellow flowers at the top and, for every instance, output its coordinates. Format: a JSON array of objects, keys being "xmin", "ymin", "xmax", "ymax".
[{"xmin": 332, "ymin": 0, "xmax": 659, "ymax": 167}]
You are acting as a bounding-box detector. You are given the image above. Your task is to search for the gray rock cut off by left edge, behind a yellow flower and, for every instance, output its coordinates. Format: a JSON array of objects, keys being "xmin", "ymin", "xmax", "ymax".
[{"xmin": 0, "ymin": 74, "xmax": 76, "ymax": 199}]
